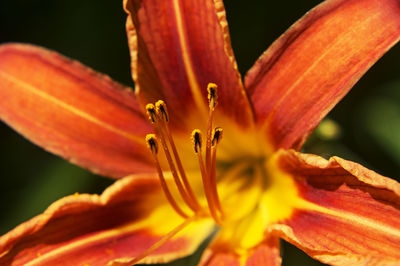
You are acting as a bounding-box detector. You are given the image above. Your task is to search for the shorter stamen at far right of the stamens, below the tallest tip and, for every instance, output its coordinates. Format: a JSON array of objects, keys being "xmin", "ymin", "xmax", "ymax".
[{"xmin": 210, "ymin": 127, "xmax": 224, "ymax": 216}]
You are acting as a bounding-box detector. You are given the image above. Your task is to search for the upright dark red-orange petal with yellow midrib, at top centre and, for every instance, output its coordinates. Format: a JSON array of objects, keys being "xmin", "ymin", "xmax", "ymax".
[{"xmin": 124, "ymin": 0, "xmax": 252, "ymax": 130}]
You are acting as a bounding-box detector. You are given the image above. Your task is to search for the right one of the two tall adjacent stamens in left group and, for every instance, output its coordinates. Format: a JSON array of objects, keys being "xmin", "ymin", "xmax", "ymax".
[{"xmin": 156, "ymin": 100, "xmax": 200, "ymax": 211}]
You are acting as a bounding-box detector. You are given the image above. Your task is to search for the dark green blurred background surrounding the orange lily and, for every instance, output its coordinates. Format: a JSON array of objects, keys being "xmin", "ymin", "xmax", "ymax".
[{"xmin": 0, "ymin": 0, "xmax": 400, "ymax": 265}]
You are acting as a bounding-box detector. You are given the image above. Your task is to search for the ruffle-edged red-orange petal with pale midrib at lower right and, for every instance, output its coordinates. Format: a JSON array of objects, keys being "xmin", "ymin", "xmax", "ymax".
[{"xmin": 270, "ymin": 151, "xmax": 400, "ymax": 265}]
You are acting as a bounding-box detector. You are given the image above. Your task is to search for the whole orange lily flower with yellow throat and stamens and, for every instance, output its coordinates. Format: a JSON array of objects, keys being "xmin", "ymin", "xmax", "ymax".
[{"xmin": 0, "ymin": 0, "xmax": 400, "ymax": 265}]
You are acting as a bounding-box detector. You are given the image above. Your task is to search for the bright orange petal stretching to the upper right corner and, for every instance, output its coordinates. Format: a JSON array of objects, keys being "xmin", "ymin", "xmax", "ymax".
[{"xmin": 245, "ymin": 0, "xmax": 400, "ymax": 149}]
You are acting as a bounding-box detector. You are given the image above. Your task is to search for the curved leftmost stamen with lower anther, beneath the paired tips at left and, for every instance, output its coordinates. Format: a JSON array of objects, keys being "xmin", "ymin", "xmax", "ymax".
[{"xmin": 146, "ymin": 134, "xmax": 189, "ymax": 218}]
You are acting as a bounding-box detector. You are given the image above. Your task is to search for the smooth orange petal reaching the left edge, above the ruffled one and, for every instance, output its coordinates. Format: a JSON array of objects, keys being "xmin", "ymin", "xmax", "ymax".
[{"xmin": 0, "ymin": 44, "xmax": 153, "ymax": 177}]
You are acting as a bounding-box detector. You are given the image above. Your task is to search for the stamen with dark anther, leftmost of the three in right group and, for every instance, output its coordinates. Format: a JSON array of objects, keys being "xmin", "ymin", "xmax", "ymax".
[{"xmin": 192, "ymin": 129, "xmax": 222, "ymax": 225}]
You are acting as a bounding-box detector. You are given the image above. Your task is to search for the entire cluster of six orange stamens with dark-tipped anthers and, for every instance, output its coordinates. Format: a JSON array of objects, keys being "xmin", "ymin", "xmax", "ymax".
[{"xmin": 146, "ymin": 83, "xmax": 224, "ymax": 225}]
